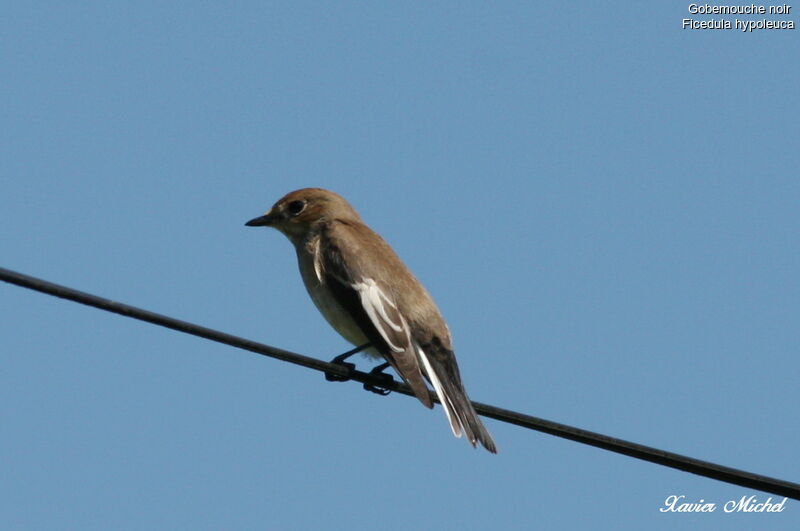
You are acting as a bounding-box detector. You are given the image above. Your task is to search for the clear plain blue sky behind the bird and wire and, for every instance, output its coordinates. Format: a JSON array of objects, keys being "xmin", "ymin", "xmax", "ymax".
[{"xmin": 0, "ymin": 2, "xmax": 800, "ymax": 529}]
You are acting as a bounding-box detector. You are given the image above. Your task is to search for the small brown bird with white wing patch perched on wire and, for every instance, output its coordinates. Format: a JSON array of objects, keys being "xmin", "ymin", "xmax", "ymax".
[{"xmin": 245, "ymin": 188, "xmax": 497, "ymax": 453}]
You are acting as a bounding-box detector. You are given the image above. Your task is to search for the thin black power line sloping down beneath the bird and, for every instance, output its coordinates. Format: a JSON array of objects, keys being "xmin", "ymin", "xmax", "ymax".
[{"xmin": 0, "ymin": 267, "xmax": 800, "ymax": 500}]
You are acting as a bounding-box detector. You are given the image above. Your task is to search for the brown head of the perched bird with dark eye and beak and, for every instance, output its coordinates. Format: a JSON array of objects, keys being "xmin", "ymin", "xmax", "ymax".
[{"xmin": 245, "ymin": 188, "xmax": 359, "ymax": 241}]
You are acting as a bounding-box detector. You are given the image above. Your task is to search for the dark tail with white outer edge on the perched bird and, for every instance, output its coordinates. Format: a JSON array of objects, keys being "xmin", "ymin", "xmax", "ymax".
[{"xmin": 417, "ymin": 347, "xmax": 497, "ymax": 454}]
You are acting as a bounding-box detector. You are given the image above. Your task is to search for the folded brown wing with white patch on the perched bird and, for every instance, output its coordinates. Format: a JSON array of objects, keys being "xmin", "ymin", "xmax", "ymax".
[{"xmin": 319, "ymin": 222, "xmax": 433, "ymax": 408}]
